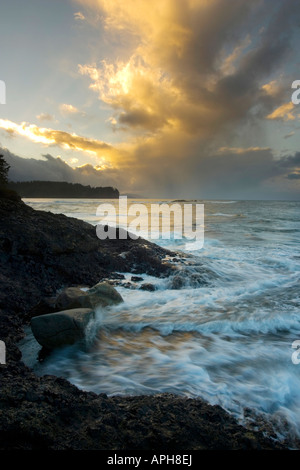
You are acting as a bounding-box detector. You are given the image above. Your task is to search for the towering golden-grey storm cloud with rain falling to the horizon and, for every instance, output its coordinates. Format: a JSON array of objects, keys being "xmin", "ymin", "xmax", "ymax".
[{"xmin": 71, "ymin": 0, "xmax": 300, "ymax": 195}]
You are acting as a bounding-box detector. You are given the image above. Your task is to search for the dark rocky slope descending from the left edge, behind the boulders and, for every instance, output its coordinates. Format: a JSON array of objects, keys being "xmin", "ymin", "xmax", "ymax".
[{"xmin": 0, "ymin": 198, "xmax": 172, "ymax": 336}]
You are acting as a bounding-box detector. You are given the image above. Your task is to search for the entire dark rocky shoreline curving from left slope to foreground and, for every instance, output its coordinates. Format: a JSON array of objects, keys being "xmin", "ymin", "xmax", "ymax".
[{"xmin": 0, "ymin": 197, "xmax": 289, "ymax": 452}]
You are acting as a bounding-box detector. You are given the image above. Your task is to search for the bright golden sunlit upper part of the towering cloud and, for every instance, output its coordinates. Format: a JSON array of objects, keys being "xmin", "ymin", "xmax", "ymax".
[{"xmin": 75, "ymin": 0, "xmax": 264, "ymax": 138}]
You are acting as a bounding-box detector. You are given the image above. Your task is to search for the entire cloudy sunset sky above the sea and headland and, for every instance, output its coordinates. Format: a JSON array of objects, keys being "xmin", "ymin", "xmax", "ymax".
[{"xmin": 0, "ymin": 0, "xmax": 300, "ymax": 200}]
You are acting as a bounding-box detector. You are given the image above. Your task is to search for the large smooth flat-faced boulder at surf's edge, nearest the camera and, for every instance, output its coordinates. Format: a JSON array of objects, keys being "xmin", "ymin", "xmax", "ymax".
[{"xmin": 31, "ymin": 308, "xmax": 94, "ymax": 349}]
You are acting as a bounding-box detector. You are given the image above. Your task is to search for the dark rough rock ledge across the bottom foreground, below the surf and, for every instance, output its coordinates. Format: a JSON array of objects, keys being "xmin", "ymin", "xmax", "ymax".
[{"xmin": 0, "ymin": 365, "xmax": 282, "ymax": 452}]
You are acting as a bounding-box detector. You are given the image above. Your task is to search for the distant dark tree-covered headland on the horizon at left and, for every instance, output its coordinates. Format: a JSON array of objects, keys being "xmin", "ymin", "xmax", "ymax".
[{"xmin": 6, "ymin": 181, "xmax": 119, "ymax": 199}]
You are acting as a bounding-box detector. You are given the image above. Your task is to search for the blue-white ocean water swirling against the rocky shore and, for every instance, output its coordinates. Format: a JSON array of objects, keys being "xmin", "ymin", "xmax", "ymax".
[{"xmin": 22, "ymin": 199, "xmax": 300, "ymax": 437}]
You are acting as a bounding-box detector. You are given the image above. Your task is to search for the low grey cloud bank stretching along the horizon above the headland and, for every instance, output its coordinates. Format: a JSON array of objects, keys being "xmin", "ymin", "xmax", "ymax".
[{"xmin": 0, "ymin": 143, "xmax": 300, "ymax": 199}]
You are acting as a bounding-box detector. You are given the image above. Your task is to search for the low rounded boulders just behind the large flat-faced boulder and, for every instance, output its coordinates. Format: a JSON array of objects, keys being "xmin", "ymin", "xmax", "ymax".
[{"xmin": 55, "ymin": 282, "xmax": 123, "ymax": 310}]
